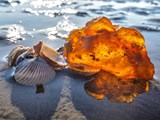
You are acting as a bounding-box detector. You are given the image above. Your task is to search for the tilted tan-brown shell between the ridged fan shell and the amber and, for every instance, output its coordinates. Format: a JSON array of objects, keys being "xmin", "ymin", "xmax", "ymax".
[{"xmin": 33, "ymin": 41, "xmax": 67, "ymax": 70}]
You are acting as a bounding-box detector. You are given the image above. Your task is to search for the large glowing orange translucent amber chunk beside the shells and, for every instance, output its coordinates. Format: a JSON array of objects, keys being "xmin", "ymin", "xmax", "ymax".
[{"xmin": 64, "ymin": 17, "xmax": 154, "ymax": 80}]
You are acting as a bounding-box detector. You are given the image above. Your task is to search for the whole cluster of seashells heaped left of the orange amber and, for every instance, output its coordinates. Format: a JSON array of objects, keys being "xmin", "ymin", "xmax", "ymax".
[{"xmin": 7, "ymin": 41, "xmax": 66, "ymax": 86}]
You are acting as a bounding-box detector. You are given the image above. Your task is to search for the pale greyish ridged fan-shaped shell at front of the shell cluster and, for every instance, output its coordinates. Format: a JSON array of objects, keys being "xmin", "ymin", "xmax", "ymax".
[{"xmin": 14, "ymin": 57, "xmax": 55, "ymax": 86}]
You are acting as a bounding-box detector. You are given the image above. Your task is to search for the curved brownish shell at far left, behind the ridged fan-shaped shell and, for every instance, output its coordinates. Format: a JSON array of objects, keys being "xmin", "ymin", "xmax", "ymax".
[{"xmin": 7, "ymin": 45, "xmax": 30, "ymax": 66}]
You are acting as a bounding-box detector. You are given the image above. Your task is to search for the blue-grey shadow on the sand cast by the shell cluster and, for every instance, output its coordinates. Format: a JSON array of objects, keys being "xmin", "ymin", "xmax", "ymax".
[{"xmin": 5, "ymin": 68, "xmax": 63, "ymax": 120}]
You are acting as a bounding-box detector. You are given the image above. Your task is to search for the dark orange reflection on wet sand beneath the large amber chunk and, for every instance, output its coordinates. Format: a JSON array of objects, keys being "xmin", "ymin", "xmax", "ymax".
[{"xmin": 84, "ymin": 71, "xmax": 150, "ymax": 103}]
